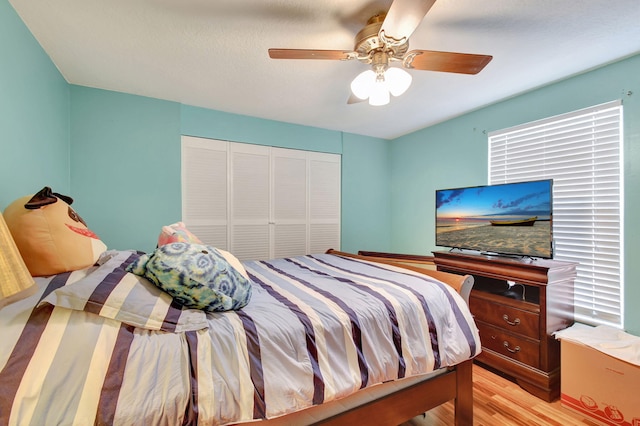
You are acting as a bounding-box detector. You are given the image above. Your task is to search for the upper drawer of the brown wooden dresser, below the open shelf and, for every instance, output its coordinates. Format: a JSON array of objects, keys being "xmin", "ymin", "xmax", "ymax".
[{"xmin": 469, "ymin": 296, "xmax": 540, "ymax": 340}]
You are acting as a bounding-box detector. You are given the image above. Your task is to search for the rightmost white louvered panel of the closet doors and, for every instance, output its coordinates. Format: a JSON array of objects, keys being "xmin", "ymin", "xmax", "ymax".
[{"xmin": 309, "ymin": 152, "xmax": 341, "ymax": 253}]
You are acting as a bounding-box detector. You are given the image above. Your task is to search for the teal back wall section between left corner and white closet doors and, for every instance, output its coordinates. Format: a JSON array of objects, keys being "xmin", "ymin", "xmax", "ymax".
[{"xmin": 71, "ymin": 86, "xmax": 182, "ymax": 251}]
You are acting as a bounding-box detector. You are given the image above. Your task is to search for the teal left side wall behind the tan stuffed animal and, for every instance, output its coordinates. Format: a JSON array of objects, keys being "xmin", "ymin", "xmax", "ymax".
[{"xmin": 0, "ymin": 0, "xmax": 70, "ymax": 211}]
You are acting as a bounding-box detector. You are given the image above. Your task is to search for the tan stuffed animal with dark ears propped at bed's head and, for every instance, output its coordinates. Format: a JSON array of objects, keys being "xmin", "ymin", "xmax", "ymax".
[{"xmin": 4, "ymin": 187, "xmax": 107, "ymax": 277}]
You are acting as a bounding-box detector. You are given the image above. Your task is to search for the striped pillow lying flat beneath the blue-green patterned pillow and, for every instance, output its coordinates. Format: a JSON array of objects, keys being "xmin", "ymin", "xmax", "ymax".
[{"xmin": 40, "ymin": 250, "xmax": 208, "ymax": 333}]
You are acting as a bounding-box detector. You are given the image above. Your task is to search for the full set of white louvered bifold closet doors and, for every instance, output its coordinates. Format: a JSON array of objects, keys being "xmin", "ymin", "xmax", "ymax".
[{"xmin": 182, "ymin": 136, "xmax": 341, "ymax": 260}]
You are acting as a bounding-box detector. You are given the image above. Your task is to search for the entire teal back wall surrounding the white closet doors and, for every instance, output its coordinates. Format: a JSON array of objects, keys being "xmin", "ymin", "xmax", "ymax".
[{"xmin": 71, "ymin": 86, "xmax": 390, "ymax": 251}]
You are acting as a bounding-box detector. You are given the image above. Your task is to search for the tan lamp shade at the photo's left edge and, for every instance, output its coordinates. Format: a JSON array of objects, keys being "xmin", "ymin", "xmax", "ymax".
[{"xmin": 0, "ymin": 214, "xmax": 36, "ymax": 309}]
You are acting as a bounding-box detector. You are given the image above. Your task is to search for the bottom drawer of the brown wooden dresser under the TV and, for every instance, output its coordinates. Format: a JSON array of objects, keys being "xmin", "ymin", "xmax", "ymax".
[{"xmin": 477, "ymin": 322, "xmax": 540, "ymax": 368}]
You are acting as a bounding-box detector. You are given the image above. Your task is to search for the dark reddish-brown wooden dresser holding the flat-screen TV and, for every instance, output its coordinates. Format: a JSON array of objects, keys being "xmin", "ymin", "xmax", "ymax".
[{"xmin": 433, "ymin": 251, "xmax": 576, "ymax": 402}]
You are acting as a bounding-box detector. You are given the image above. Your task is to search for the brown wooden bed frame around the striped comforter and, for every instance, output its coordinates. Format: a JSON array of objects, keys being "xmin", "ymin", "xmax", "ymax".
[{"xmin": 252, "ymin": 249, "xmax": 473, "ymax": 426}]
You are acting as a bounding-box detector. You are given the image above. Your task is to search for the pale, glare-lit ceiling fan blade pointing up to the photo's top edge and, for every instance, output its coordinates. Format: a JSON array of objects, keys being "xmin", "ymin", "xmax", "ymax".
[{"xmin": 379, "ymin": 0, "xmax": 436, "ymax": 45}]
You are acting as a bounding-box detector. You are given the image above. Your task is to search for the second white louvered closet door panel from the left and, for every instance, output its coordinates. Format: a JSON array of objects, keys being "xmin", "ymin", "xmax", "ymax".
[{"xmin": 229, "ymin": 143, "xmax": 272, "ymax": 260}]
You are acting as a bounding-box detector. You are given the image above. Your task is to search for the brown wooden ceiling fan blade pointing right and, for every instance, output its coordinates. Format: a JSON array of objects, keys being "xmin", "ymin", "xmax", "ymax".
[{"xmin": 402, "ymin": 50, "xmax": 493, "ymax": 74}]
